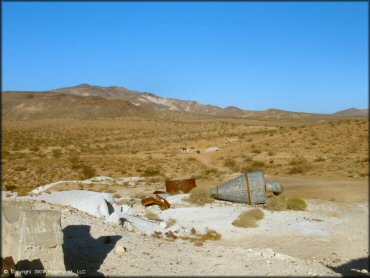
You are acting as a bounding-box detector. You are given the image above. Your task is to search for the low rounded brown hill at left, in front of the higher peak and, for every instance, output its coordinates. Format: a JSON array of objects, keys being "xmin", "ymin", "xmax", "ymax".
[{"xmin": 2, "ymin": 92, "xmax": 152, "ymax": 120}]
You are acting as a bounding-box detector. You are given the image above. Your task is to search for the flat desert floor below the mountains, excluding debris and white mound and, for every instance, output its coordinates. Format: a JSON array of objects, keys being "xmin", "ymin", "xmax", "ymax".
[{"xmin": 2, "ymin": 116, "xmax": 369, "ymax": 276}]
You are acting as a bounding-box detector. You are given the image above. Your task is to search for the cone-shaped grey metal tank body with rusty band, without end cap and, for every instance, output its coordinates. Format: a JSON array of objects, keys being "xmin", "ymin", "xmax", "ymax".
[{"xmin": 212, "ymin": 171, "xmax": 267, "ymax": 204}]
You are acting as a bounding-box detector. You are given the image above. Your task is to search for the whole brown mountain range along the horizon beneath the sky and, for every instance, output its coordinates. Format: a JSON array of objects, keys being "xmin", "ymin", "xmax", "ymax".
[{"xmin": 2, "ymin": 84, "xmax": 368, "ymax": 119}]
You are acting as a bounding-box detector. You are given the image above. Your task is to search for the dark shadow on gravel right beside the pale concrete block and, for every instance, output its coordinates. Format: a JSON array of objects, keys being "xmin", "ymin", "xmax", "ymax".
[{"xmin": 63, "ymin": 225, "xmax": 121, "ymax": 277}]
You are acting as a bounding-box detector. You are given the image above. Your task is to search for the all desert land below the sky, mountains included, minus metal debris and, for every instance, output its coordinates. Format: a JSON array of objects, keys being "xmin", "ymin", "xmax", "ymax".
[{"xmin": 2, "ymin": 84, "xmax": 369, "ymax": 276}]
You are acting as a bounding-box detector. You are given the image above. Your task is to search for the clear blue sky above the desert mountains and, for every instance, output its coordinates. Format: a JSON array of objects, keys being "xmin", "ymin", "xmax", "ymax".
[{"xmin": 2, "ymin": 2, "xmax": 368, "ymax": 113}]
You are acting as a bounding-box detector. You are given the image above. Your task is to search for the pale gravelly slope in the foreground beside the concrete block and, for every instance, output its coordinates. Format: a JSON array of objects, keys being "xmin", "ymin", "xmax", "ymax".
[{"xmin": 3, "ymin": 201, "xmax": 336, "ymax": 276}]
